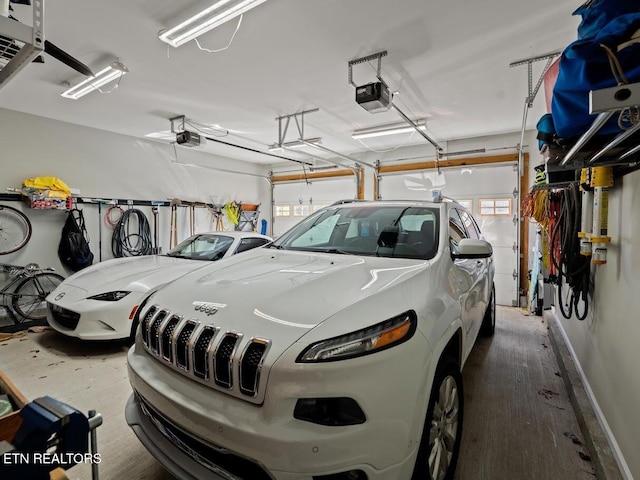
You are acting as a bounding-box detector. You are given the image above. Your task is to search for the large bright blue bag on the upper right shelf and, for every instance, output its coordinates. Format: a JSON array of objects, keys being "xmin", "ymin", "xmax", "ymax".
[{"xmin": 551, "ymin": 13, "xmax": 640, "ymax": 138}]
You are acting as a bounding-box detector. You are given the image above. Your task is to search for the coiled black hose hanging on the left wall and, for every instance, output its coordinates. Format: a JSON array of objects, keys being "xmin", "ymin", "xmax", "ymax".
[{"xmin": 111, "ymin": 208, "xmax": 153, "ymax": 258}]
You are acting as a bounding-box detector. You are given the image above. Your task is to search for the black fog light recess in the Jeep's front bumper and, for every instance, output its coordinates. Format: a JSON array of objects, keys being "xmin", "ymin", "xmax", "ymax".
[{"xmin": 293, "ymin": 397, "xmax": 366, "ymax": 428}]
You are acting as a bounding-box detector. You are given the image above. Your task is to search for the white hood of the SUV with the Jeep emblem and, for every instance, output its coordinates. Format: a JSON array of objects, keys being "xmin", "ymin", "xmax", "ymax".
[{"xmin": 146, "ymin": 249, "xmax": 428, "ymax": 342}]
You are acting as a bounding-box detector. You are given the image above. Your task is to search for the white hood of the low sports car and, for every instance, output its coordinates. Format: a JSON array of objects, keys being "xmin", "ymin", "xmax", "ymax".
[{"xmin": 66, "ymin": 255, "xmax": 209, "ymax": 295}]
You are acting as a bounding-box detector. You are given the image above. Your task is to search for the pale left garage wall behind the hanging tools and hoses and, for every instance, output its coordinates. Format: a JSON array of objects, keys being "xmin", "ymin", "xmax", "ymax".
[{"xmin": 0, "ymin": 109, "xmax": 270, "ymax": 273}]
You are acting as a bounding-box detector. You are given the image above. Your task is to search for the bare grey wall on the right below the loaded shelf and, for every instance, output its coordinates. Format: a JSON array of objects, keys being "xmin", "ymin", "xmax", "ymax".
[{"xmin": 555, "ymin": 168, "xmax": 640, "ymax": 478}]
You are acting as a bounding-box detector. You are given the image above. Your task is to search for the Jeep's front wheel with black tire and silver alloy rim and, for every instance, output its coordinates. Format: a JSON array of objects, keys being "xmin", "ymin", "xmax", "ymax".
[{"xmin": 411, "ymin": 357, "xmax": 464, "ymax": 480}]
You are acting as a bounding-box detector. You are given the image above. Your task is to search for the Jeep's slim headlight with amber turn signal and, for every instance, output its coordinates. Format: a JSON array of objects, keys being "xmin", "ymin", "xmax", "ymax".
[{"xmin": 296, "ymin": 310, "xmax": 416, "ymax": 363}]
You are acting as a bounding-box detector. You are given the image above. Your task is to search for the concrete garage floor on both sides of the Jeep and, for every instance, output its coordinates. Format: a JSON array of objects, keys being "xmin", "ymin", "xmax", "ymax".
[{"xmin": 0, "ymin": 307, "xmax": 595, "ymax": 480}]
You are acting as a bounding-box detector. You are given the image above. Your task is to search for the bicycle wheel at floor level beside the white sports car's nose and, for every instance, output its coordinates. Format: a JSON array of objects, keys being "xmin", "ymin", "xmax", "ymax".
[{"xmin": 11, "ymin": 273, "xmax": 64, "ymax": 323}]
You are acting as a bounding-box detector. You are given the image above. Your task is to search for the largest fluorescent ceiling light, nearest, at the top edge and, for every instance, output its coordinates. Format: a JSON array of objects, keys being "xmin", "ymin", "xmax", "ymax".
[{"xmin": 158, "ymin": 0, "xmax": 267, "ymax": 48}]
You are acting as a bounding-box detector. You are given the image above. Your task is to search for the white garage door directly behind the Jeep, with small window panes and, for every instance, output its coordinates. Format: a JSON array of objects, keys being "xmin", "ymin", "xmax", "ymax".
[{"xmin": 379, "ymin": 163, "xmax": 519, "ymax": 306}]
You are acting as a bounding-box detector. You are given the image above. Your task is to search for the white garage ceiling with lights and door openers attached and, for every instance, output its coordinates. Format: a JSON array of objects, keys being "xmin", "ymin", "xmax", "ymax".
[{"xmin": 0, "ymin": 0, "xmax": 579, "ymax": 163}]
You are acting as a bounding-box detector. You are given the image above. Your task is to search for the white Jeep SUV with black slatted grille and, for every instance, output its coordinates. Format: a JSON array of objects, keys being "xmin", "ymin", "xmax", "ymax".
[{"xmin": 126, "ymin": 200, "xmax": 495, "ymax": 480}]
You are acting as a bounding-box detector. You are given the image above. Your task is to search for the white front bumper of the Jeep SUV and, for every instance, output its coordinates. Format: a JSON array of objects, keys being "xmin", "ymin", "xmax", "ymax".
[{"xmin": 127, "ymin": 335, "xmax": 430, "ymax": 480}]
